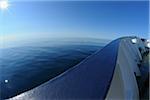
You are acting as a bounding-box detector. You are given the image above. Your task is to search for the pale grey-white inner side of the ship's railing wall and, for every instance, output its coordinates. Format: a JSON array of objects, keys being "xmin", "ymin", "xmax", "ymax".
[{"xmin": 106, "ymin": 38, "xmax": 146, "ymax": 100}]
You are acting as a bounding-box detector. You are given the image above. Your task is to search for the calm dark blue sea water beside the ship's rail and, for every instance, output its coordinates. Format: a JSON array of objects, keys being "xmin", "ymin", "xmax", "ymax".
[{"xmin": 0, "ymin": 38, "xmax": 104, "ymax": 99}]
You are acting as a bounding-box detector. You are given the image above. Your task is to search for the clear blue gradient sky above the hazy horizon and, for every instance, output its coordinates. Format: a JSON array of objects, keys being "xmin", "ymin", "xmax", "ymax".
[{"xmin": 0, "ymin": 0, "xmax": 149, "ymax": 39}]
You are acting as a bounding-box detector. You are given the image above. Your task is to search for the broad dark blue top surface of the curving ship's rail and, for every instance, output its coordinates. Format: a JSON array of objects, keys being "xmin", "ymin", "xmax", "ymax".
[{"xmin": 9, "ymin": 39, "xmax": 120, "ymax": 100}]
